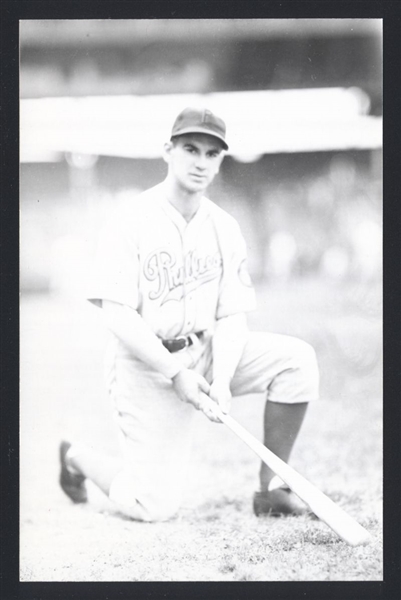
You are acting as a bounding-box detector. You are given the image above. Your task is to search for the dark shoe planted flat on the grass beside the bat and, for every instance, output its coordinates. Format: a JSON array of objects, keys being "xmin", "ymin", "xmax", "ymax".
[{"xmin": 253, "ymin": 487, "xmax": 311, "ymax": 517}]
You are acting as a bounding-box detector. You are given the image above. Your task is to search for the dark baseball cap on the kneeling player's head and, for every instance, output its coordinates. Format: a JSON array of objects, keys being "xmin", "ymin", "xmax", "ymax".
[{"xmin": 171, "ymin": 107, "xmax": 228, "ymax": 150}]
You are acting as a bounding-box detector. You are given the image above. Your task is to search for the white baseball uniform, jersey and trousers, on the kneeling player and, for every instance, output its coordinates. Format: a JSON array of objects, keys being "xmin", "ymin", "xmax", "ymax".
[{"xmin": 83, "ymin": 184, "xmax": 318, "ymax": 521}]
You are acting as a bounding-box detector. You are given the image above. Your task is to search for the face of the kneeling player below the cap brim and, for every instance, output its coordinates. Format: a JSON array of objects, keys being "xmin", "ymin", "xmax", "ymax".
[{"xmin": 165, "ymin": 133, "xmax": 223, "ymax": 193}]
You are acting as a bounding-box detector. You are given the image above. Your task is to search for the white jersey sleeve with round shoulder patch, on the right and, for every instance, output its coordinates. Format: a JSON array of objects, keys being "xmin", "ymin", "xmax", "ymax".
[{"xmin": 216, "ymin": 223, "xmax": 256, "ymax": 319}]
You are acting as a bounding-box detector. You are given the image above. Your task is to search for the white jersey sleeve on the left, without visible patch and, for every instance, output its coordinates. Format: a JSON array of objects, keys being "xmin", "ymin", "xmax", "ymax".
[{"xmin": 86, "ymin": 207, "xmax": 139, "ymax": 309}]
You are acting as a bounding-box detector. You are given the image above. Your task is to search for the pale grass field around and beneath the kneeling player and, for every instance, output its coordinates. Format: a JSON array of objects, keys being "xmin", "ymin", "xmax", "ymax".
[{"xmin": 20, "ymin": 281, "xmax": 383, "ymax": 581}]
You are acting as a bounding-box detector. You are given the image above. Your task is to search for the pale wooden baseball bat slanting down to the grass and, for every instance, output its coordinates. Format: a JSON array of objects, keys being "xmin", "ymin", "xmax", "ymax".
[{"xmin": 202, "ymin": 393, "xmax": 371, "ymax": 546}]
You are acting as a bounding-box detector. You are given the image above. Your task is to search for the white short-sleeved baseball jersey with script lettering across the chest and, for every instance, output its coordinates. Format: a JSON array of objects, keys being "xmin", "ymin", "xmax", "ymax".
[{"xmin": 87, "ymin": 183, "xmax": 255, "ymax": 338}]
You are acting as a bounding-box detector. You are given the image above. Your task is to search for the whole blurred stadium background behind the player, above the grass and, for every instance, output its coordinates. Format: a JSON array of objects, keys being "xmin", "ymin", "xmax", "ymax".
[{"xmin": 20, "ymin": 19, "xmax": 382, "ymax": 293}]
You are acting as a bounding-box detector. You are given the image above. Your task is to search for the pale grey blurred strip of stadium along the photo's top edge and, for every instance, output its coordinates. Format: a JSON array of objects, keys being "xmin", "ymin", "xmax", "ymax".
[{"xmin": 20, "ymin": 19, "xmax": 382, "ymax": 47}]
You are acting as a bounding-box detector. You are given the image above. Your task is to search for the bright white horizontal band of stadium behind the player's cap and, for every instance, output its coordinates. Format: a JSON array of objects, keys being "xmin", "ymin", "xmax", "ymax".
[{"xmin": 20, "ymin": 88, "xmax": 382, "ymax": 162}]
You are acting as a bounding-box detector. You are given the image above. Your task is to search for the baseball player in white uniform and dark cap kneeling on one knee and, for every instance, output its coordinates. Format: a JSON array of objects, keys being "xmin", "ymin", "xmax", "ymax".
[{"xmin": 60, "ymin": 108, "xmax": 318, "ymax": 521}]
